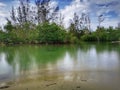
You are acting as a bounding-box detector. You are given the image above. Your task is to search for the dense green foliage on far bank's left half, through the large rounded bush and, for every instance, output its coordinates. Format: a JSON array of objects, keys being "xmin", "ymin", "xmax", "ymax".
[{"xmin": 0, "ymin": 23, "xmax": 68, "ymax": 44}]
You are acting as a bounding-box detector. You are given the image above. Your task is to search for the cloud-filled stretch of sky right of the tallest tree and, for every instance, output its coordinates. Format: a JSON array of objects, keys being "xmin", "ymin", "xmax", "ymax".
[{"xmin": 61, "ymin": 0, "xmax": 120, "ymax": 30}]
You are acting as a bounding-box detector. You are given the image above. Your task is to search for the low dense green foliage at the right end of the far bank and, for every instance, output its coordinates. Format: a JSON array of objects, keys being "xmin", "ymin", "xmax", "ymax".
[{"xmin": 81, "ymin": 27, "xmax": 120, "ymax": 42}]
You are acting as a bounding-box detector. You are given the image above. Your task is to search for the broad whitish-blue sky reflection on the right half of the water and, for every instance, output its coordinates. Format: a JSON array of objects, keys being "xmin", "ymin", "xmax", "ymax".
[{"xmin": 57, "ymin": 48, "xmax": 119, "ymax": 71}]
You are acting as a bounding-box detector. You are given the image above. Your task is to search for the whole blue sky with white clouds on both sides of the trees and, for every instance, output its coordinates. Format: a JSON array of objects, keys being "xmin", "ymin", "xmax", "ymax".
[{"xmin": 0, "ymin": 0, "xmax": 120, "ymax": 30}]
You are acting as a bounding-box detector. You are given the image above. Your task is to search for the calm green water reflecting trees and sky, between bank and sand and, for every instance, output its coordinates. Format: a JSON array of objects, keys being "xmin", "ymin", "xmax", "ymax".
[{"xmin": 0, "ymin": 43, "xmax": 120, "ymax": 89}]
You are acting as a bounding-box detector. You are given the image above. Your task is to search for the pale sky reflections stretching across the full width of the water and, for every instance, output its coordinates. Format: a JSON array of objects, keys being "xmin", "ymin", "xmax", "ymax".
[{"xmin": 0, "ymin": 47, "xmax": 120, "ymax": 80}]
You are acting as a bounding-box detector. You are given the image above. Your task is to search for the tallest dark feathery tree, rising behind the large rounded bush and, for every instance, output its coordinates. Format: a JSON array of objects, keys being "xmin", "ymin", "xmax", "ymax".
[{"xmin": 35, "ymin": 0, "xmax": 59, "ymax": 23}]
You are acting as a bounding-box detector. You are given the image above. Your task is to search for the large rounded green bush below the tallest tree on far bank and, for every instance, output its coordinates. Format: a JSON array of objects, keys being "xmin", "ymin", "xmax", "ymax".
[{"xmin": 37, "ymin": 23, "xmax": 67, "ymax": 43}]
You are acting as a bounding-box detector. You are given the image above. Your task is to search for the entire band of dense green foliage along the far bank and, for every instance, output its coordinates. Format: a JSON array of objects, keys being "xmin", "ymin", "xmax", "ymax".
[{"xmin": 0, "ymin": 23, "xmax": 120, "ymax": 44}]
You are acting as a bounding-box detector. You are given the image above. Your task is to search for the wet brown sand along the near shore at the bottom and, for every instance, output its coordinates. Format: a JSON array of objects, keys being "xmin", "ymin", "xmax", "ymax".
[{"xmin": 0, "ymin": 72, "xmax": 120, "ymax": 90}]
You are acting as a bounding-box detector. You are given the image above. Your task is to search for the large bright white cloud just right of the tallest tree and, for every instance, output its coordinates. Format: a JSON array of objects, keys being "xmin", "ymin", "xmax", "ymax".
[{"xmin": 60, "ymin": 0, "xmax": 89, "ymax": 28}]
